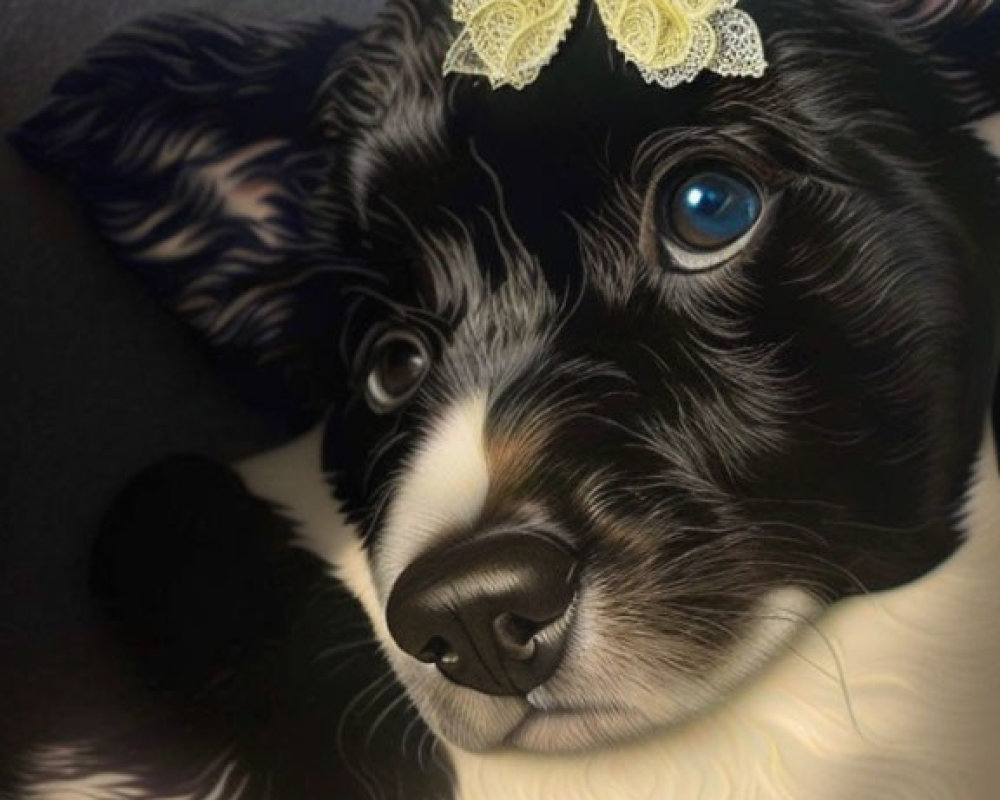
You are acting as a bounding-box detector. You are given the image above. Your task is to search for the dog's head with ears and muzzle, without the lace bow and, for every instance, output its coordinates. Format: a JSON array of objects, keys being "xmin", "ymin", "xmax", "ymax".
[{"xmin": 13, "ymin": 0, "xmax": 1000, "ymax": 750}]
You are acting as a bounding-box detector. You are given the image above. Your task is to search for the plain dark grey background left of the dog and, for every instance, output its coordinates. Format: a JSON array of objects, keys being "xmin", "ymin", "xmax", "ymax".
[{"xmin": 0, "ymin": 0, "xmax": 382, "ymax": 752}]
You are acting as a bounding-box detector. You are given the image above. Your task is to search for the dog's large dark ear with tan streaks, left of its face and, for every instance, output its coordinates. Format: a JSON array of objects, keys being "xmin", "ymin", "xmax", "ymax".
[{"xmin": 11, "ymin": 14, "xmax": 354, "ymax": 434}]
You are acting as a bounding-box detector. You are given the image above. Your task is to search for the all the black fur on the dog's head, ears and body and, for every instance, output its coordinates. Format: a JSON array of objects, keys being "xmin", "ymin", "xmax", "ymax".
[{"xmin": 15, "ymin": 0, "xmax": 1000, "ymax": 800}]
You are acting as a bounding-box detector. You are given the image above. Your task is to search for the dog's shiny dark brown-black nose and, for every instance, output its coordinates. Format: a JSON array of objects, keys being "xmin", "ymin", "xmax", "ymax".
[{"xmin": 386, "ymin": 530, "xmax": 576, "ymax": 695}]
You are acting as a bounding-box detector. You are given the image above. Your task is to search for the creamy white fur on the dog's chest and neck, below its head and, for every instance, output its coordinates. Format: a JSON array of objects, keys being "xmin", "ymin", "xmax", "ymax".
[{"xmin": 236, "ymin": 424, "xmax": 1000, "ymax": 800}]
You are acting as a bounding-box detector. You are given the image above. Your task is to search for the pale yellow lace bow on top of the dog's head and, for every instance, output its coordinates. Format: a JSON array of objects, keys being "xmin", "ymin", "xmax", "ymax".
[{"xmin": 445, "ymin": 0, "xmax": 767, "ymax": 89}]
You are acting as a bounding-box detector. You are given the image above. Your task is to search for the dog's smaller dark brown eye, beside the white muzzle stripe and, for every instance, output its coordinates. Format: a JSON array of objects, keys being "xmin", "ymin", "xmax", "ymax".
[{"xmin": 365, "ymin": 330, "xmax": 431, "ymax": 414}]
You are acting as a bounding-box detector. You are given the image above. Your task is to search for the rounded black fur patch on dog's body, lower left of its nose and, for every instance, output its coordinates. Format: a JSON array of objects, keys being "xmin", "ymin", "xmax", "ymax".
[{"xmin": 87, "ymin": 457, "xmax": 448, "ymax": 798}]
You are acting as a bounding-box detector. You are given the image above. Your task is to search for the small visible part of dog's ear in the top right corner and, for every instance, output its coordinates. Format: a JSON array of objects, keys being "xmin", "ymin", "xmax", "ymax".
[{"xmin": 873, "ymin": 0, "xmax": 1000, "ymax": 122}]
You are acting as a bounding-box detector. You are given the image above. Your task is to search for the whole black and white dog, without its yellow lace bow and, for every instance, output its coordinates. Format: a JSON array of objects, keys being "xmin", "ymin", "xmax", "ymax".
[{"xmin": 15, "ymin": 0, "xmax": 1000, "ymax": 800}]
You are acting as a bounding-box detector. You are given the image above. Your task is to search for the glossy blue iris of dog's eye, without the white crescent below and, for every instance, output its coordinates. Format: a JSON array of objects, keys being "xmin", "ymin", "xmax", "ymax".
[{"xmin": 663, "ymin": 167, "xmax": 764, "ymax": 252}]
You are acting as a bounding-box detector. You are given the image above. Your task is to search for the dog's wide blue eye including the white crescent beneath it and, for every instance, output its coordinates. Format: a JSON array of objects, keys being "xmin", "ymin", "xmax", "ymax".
[{"xmin": 657, "ymin": 164, "xmax": 765, "ymax": 271}]
